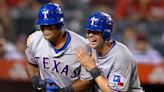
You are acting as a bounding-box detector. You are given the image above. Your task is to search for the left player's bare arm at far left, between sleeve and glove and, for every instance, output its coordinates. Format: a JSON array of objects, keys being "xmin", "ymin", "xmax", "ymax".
[{"xmin": 26, "ymin": 62, "xmax": 39, "ymax": 79}]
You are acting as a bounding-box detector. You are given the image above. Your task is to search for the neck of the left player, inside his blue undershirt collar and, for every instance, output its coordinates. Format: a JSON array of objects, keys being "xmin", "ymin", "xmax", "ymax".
[{"xmin": 53, "ymin": 31, "xmax": 67, "ymax": 49}]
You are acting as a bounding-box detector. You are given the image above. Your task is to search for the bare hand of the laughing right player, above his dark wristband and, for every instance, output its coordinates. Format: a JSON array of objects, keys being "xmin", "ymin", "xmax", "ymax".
[{"xmin": 76, "ymin": 47, "xmax": 96, "ymax": 71}]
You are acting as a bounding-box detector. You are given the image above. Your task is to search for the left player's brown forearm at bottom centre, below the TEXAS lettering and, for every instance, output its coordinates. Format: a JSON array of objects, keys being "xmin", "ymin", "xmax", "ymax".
[{"xmin": 72, "ymin": 79, "xmax": 93, "ymax": 92}]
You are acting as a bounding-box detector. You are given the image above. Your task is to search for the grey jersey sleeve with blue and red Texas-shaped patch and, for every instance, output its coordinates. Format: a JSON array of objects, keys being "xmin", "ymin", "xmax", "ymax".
[{"xmin": 107, "ymin": 57, "xmax": 133, "ymax": 91}]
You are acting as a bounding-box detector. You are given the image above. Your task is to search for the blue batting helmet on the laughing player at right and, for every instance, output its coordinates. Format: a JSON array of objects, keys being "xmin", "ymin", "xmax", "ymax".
[{"xmin": 85, "ymin": 12, "xmax": 113, "ymax": 40}]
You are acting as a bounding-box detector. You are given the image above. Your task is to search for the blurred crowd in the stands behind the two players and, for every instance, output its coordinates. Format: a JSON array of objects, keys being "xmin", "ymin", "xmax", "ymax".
[{"xmin": 0, "ymin": 0, "xmax": 164, "ymax": 64}]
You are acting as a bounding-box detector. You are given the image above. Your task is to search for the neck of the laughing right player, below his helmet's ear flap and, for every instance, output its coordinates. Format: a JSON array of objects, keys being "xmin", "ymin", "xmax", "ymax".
[{"xmin": 97, "ymin": 41, "xmax": 112, "ymax": 56}]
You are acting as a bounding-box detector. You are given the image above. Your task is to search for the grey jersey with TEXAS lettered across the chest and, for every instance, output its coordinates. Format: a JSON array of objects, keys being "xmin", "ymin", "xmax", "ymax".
[{"xmin": 25, "ymin": 29, "xmax": 91, "ymax": 88}]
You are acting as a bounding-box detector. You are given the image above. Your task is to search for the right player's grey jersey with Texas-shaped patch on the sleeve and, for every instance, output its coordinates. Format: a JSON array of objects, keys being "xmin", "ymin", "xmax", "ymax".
[{"xmin": 81, "ymin": 41, "xmax": 142, "ymax": 92}]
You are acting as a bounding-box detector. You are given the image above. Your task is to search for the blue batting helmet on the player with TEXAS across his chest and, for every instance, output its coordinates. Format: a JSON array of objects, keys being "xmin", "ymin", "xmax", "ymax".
[{"xmin": 36, "ymin": 3, "xmax": 64, "ymax": 28}]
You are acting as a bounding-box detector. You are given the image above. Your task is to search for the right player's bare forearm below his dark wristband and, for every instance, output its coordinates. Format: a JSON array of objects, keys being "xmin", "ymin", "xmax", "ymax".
[{"xmin": 95, "ymin": 75, "xmax": 112, "ymax": 92}]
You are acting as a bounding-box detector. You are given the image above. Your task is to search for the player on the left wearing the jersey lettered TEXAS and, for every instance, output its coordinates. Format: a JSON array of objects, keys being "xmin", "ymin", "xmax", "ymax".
[{"xmin": 25, "ymin": 3, "xmax": 91, "ymax": 92}]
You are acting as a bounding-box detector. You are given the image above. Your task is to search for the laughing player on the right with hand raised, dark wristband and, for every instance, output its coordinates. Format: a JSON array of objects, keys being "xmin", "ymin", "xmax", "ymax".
[{"xmin": 76, "ymin": 12, "xmax": 142, "ymax": 92}]
